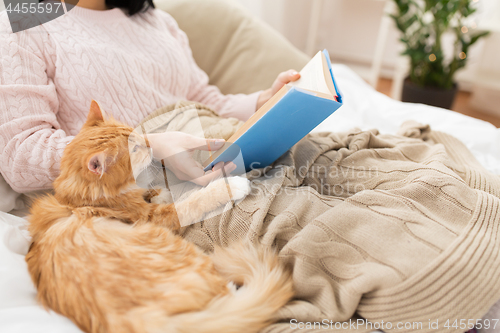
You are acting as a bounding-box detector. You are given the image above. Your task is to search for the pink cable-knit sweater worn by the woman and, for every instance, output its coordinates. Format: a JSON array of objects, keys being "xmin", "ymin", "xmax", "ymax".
[{"xmin": 0, "ymin": 7, "xmax": 259, "ymax": 192}]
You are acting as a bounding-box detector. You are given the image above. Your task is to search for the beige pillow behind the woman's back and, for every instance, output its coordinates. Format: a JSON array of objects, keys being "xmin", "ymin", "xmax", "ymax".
[{"xmin": 155, "ymin": 0, "xmax": 309, "ymax": 94}]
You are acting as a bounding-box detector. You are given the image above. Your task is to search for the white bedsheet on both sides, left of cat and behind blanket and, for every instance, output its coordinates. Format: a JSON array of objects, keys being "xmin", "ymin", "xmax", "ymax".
[{"xmin": 0, "ymin": 65, "xmax": 500, "ymax": 333}]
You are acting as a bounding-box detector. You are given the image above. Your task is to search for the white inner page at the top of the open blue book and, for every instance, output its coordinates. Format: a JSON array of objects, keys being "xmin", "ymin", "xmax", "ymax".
[{"xmin": 288, "ymin": 51, "xmax": 337, "ymax": 96}]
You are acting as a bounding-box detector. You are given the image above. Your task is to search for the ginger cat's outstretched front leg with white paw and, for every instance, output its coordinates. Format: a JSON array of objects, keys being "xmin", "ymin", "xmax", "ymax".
[{"xmin": 175, "ymin": 177, "xmax": 251, "ymax": 226}]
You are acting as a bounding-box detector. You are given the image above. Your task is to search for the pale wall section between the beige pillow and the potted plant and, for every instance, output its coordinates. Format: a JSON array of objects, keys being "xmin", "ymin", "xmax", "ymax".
[{"xmin": 235, "ymin": 0, "xmax": 397, "ymax": 71}]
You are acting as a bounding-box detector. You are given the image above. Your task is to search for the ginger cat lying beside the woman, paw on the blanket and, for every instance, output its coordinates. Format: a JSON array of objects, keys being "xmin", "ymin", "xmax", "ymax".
[{"xmin": 26, "ymin": 101, "xmax": 293, "ymax": 333}]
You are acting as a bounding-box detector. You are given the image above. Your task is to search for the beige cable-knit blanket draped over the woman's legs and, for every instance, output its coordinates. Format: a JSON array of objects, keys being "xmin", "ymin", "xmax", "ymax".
[{"xmin": 139, "ymin": 102, "xmax": 500, "ymax": 333}]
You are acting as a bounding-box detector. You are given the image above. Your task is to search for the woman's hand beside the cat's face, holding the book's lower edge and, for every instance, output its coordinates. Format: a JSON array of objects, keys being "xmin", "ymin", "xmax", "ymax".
[{"xmin": 147, "ymin": 132, "xmax": 236, "ymax": 186}]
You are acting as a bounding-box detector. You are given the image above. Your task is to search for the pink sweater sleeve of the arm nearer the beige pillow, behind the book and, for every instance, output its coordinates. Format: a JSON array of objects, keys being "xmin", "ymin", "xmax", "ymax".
[{"xmin": 162, "ymin": 12, "xmax": 261, "ymax": 121}]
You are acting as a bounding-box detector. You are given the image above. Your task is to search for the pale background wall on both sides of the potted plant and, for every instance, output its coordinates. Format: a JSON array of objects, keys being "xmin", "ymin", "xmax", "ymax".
[{"xmin": 235, "ymin": 0, "xmax": 500, "ymax": 94}]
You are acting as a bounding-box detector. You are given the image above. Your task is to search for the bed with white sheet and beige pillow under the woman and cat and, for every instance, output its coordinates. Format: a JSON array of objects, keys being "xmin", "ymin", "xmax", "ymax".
[{"xmin": 0, "ymin": 0, "xmax": 500, "ymax": 333}]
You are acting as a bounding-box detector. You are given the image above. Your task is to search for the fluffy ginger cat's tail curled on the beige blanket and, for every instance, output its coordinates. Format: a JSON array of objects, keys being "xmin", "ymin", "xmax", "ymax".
[{"xmin": 167, "ymin": 243, "xmax": 293, "ymax": 333}]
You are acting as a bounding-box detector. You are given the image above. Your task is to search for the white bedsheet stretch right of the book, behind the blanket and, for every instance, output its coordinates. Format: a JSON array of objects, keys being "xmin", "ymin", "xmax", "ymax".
[{"xmin": 314, "ymin": 65, "xmax": 500, "ymax": 174}]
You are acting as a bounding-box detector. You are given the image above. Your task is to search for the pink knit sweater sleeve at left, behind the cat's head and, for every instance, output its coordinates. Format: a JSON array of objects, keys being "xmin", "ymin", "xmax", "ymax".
[{"xmin": 0, "ymin": 18, "xmax": 73, "ymax": 192}]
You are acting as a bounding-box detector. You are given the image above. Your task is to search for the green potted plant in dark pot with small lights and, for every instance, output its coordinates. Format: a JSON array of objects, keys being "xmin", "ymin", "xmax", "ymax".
[{"xmin": 391, "ymin": 0, "xmax": 488, "ymax": 109}]
